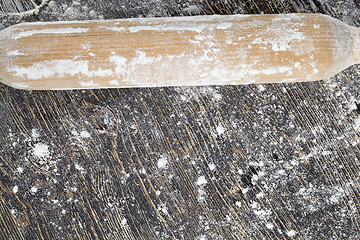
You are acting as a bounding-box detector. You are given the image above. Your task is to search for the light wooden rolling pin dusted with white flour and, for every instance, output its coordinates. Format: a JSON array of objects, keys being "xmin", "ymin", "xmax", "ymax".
[{"xmin": 0, "ymin": 14, "xmax": 360, "ymax": 90}]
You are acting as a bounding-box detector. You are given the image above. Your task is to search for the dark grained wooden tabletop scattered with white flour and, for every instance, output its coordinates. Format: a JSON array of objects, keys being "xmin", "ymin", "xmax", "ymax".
[{"xmin": 0, "ymin": 0, "xmax": 360, "ymax": 239}]
